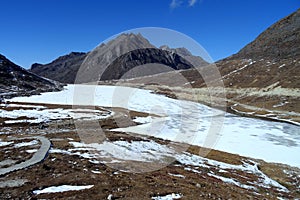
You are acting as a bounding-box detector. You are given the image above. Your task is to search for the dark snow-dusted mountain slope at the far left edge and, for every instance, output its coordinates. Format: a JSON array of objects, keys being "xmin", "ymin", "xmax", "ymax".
[{"xmin": 0, "ymin": 54, "xmax": 62, "ymax": 99}]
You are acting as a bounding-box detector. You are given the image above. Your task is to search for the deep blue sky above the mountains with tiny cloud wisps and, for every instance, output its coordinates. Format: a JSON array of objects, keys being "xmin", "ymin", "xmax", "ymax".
[{"xmin": 0, "ymin": 0, "xmax": 300, "ymax": 68}]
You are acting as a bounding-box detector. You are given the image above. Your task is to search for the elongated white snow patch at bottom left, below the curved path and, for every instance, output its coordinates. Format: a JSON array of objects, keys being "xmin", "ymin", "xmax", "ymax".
[{"xmin": 33, "ymin": 185, "xmax": 94, "ymax": 195}]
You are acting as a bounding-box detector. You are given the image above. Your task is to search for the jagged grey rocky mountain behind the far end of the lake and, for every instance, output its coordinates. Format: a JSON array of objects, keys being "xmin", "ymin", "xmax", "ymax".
[{"xmin": 30, "ymin": 33, "xmax": 207, "ymax": 83}]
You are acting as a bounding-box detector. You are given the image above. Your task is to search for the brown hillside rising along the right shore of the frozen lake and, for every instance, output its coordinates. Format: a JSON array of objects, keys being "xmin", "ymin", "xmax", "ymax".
[{"xmin": 118, "ymin": 9, "xmax": 300, "ymax": 124}]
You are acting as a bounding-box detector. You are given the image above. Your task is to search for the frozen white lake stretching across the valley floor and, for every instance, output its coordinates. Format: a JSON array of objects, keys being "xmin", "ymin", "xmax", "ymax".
[{"xmin": 10, "ymin": 85, "xmax": 300, "ymax": 168}]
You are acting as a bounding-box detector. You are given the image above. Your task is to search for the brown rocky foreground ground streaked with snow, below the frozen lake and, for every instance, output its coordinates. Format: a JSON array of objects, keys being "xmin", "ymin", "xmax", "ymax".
[{"xmin": 0, "ymin": 104, "xmax": 300, "ymax": 199}]
